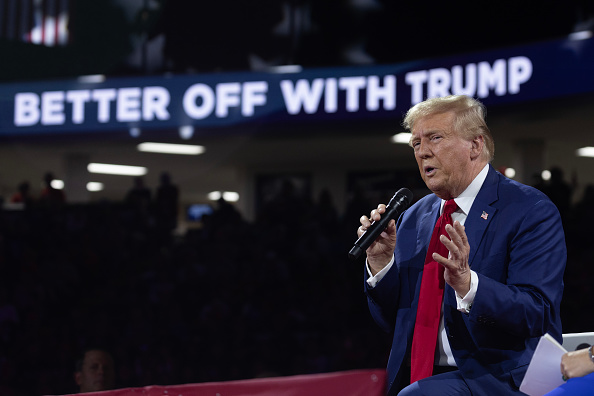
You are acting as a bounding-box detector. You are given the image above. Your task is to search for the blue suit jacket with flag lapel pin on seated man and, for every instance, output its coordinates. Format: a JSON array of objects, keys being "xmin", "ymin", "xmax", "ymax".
[{"xmin": 365, "ymin": 166, "xmax": 567, "ymax": 395}]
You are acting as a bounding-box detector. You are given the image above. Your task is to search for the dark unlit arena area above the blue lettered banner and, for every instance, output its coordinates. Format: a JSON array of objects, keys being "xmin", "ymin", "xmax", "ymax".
[{"xmin": 0, "ymin": 0, "xmax": 594, "ymax": 81}]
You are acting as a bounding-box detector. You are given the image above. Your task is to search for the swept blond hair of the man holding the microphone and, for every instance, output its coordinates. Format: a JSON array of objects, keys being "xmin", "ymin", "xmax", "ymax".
[{"xmin": 402, "ymin": 95, "xmax": 495, "ymax": 162}]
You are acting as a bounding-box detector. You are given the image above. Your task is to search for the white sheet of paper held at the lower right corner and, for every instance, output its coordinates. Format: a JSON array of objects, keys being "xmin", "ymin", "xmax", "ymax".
[{"xmin": 520, "ymin": 333, "xmax": 567, "ymax": 396}]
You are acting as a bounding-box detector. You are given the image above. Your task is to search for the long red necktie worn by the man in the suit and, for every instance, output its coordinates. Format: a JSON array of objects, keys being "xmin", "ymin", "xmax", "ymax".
[{"xmin": 410, "ymin": 199, "xmax": 458, "ymax": 384}]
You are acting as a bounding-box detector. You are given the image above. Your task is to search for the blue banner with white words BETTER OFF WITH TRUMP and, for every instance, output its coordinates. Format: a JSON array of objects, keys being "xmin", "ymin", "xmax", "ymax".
[{"xmin": 0, "ymin": 38, "xmax": 594, "ymax": 136}]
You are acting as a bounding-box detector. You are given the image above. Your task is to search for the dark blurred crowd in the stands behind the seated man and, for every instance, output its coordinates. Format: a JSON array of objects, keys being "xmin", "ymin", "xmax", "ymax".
[{"xmin": 0, "ymin": 168, "xmax": 594, "ymax": 396}]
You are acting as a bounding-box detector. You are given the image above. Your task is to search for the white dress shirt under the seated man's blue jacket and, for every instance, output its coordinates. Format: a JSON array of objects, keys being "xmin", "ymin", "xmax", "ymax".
[{"xmin": 367, "ymin": 164, "xmax": 489, "ymax": 366}]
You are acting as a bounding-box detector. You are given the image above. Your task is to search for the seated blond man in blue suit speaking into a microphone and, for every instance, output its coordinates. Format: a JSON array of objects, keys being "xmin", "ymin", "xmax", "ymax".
[{"xmin": 357, "ymin": 96, "xmax": 567, "ymax": 396}]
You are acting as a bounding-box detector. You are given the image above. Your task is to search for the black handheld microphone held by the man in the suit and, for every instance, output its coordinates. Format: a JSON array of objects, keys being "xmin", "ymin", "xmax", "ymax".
[{"xmin": 349, "ymin": 188, "xmax": 412, "ymax": 260}]
